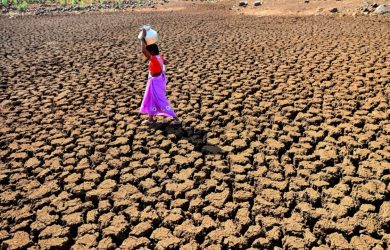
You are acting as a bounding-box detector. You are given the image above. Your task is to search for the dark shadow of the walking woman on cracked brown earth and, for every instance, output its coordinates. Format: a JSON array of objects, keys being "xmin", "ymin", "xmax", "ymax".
[{"xmin": 149, "ymin": 122, "xmax": 225, "ymax": 154}]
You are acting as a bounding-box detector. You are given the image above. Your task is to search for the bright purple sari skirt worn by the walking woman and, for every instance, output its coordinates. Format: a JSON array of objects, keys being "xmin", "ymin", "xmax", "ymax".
[{"xmin": 139, "ymin": 68, "xmax": 176, "ymax": 117}]
